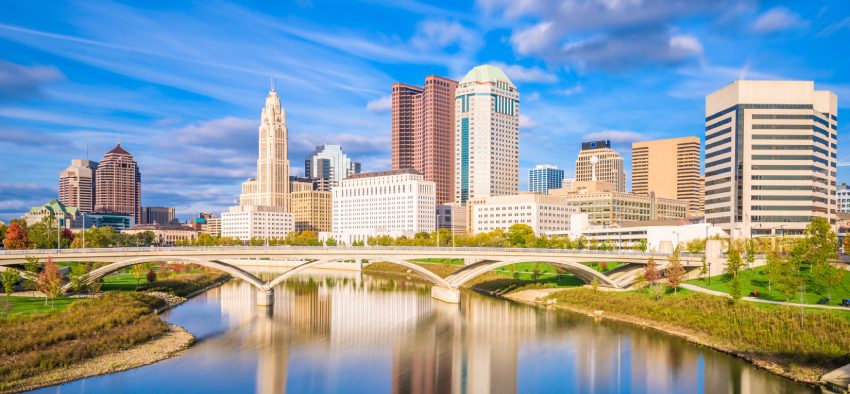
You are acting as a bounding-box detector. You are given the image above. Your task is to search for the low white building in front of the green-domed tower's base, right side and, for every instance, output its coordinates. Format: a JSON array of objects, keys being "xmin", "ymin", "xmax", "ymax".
[{"xmin": 470, "ymin": 193, "xmax": 587, "ymax": 236}]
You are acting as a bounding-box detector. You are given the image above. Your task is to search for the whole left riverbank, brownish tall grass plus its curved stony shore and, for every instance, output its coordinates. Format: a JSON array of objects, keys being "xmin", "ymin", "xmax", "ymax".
[{"xmin": 0, "ymin": 273, "xmax": 230, "ymax": 392}]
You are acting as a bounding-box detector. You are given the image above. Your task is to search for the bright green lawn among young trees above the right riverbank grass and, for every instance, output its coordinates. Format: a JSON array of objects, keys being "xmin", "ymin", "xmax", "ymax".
[{"xmin": 685, "ymin": 266, "xmax": 850, "ymax": 305}]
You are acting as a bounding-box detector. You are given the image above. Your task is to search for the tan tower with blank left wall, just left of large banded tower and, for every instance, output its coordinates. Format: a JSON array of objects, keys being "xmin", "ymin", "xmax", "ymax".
[{"xmin": 632, "ymin": 136, "xmax": 702, "ymax": 214}]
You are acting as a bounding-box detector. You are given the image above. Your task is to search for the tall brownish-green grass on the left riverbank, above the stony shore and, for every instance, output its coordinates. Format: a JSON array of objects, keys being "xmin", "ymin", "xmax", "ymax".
[{"xmin": 0, "ymin": 292, "xmax": 168, "ymax": 390}]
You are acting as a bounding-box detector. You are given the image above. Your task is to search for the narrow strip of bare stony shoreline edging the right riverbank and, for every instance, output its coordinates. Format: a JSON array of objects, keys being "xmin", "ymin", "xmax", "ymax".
[{"xmin": 500, "ymin": 289, "xmax": 821, "ymax": 386}]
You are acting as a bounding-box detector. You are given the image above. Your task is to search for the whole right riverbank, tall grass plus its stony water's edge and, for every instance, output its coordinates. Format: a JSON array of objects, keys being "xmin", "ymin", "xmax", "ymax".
[{"xmin": 502, "ymin": 289, "xmax": 850, "ymax": 385}]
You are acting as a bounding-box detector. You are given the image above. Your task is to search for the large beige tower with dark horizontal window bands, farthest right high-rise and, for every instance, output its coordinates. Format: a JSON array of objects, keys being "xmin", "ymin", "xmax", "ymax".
[{"xmin": 705, "ymin": 81, "xmax": 838, "ymax": 237}]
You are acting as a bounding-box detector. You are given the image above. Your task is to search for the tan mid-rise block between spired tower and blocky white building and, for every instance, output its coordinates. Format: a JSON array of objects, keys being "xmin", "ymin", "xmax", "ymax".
[{"xmin": 289, "ymin": 178, "xmax": 333, "ymax": 232}]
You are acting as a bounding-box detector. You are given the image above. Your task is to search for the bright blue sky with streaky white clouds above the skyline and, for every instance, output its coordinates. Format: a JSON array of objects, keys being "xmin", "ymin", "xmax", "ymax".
[{"xmin": 0, "ymin": 0, "xmax": 850, "ymax": 221}]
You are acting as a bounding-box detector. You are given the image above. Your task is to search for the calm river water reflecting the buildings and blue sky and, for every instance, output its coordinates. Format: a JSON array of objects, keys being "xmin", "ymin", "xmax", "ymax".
[{"xmin": 34, "ymin": 271, "xmax": 815, "ymax": 393}]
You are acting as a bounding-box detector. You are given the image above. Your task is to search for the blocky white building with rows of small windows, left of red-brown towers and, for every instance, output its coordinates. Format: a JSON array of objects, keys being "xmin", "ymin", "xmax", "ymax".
[{"xmin": 330, "ymin": 169, "xmax": 436, "ymax": 245}]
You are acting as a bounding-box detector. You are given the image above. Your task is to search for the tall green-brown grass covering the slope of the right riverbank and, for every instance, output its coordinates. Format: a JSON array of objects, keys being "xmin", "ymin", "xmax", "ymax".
[{"xmin": 536, "ymin": 288, "xmax": 850, "ymax": 382}]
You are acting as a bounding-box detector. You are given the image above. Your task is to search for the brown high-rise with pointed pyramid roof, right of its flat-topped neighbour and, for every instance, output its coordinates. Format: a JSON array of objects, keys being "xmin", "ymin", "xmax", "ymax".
[{"xmin": 94, "ymin": 144, "xmax": 142, "ymax": 223}]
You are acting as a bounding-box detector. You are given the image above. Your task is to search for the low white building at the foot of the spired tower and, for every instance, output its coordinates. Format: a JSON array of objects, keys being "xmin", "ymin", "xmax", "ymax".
[{"xmin": 221, "ymin": 205, "xmax": 295, "ymax": 242}]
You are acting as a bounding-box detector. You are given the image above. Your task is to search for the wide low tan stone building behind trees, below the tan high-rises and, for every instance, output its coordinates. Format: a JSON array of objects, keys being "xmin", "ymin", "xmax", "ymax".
[{"xmin": 549, "ymin": 181, "xmax": 688, "ymax": 226}]
